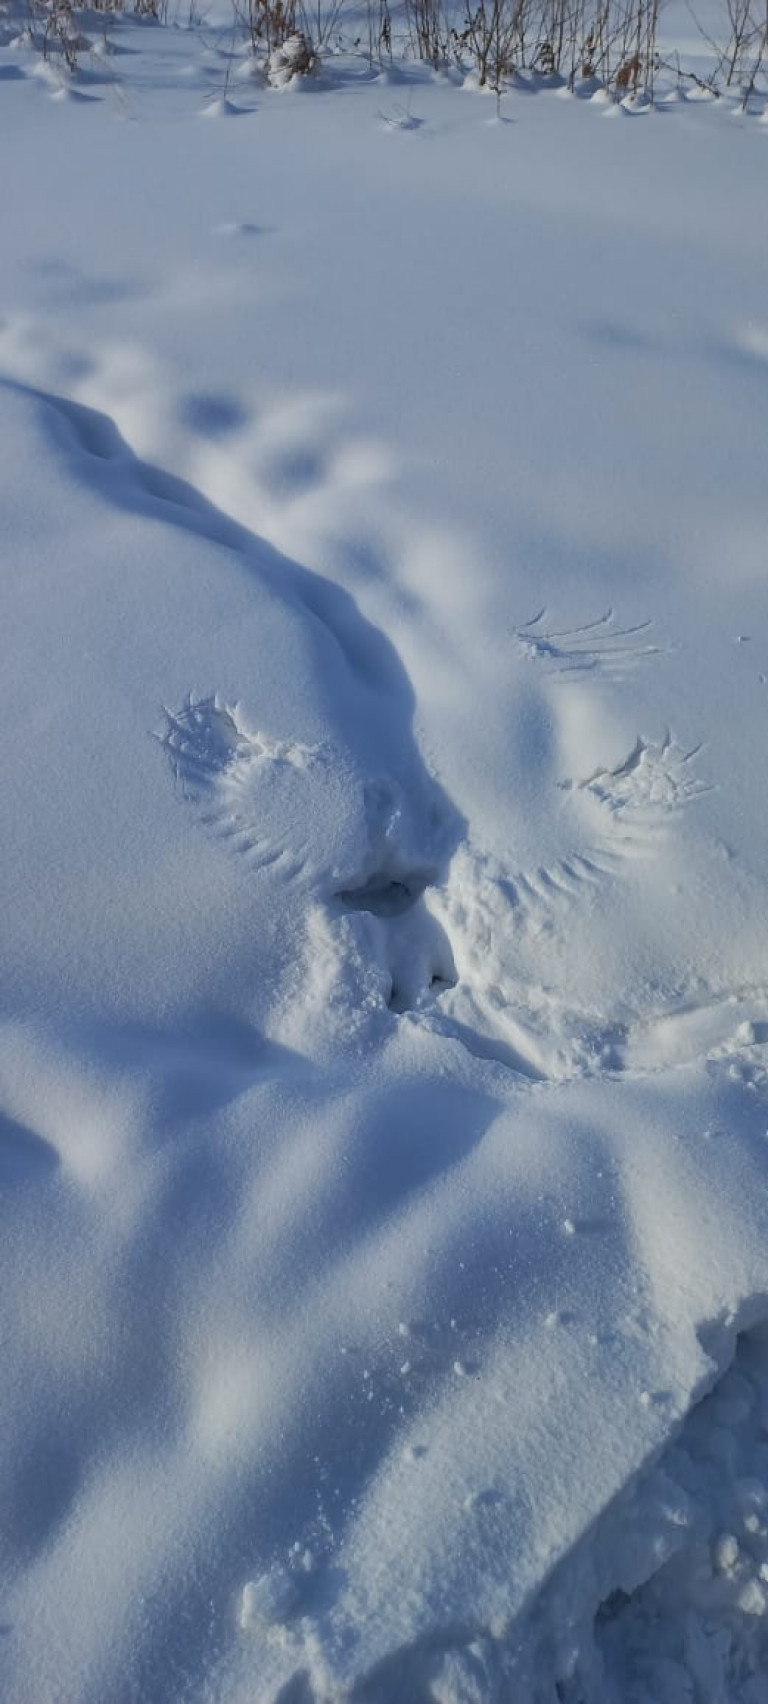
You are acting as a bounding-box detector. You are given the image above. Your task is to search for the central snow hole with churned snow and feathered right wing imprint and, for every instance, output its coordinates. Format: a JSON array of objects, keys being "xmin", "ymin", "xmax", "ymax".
[{"xmin": 320, "ymin": 736, "xmax": 715, "ymax": 1080}]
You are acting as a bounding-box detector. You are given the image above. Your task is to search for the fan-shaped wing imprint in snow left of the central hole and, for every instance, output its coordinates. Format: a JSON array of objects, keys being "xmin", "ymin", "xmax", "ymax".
[{"xmin": 158, "ymin": 694, "xmax": 318, "ymax": 876}]
